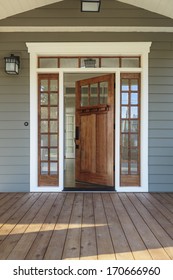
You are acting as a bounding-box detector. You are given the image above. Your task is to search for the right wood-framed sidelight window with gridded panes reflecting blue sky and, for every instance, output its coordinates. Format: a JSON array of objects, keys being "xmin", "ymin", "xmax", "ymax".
[{"xmin": 120, "ymin": 74, "xmax": 140, "ymax": 185}]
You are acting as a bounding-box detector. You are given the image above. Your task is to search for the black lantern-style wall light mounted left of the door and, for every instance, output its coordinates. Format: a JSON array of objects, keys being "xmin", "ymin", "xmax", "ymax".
[{"xmin": 4, "ymin": 54, "xmax": 20, "ymax": 75}]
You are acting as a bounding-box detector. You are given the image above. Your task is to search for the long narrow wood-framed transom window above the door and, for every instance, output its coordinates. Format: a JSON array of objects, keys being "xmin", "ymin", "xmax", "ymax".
[{"xmin": 38, "ymin": 56, "xmax": 141, "ymax": 68}]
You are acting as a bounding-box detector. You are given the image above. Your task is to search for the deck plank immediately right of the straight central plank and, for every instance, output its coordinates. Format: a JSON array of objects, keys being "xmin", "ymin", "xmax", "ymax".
[{"xmin": 93, "ymin": 194, "xmax": 116, "ymax": 260}]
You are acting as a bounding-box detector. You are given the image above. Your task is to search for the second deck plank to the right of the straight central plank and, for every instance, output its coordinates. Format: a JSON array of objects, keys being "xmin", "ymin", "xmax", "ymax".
[{"xmin": 102, "ymin": 194, "xmax": 134, "ymax": 260}]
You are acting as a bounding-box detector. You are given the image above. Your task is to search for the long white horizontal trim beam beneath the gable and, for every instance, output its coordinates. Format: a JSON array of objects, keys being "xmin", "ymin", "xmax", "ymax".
[{"xmin": 0, "ymin": 26, "xmax": 173, "ymax": 33}]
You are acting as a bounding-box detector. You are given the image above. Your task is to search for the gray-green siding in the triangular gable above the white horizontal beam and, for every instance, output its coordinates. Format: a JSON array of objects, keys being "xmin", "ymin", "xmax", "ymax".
[{"xmin": 0, "ymin": 0, "xmax": 172, "ymax": 26}]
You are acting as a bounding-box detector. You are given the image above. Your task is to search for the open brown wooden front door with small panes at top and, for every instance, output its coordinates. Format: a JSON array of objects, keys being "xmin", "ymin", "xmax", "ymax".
[{"xmin": 75, "ymin": 74, "xmax": 115, "ymax": 186}]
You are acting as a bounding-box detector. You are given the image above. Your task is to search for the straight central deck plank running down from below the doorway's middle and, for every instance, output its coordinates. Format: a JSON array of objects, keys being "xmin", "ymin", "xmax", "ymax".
[{"xmin": 80, "ymin": 194, "xmax": 97, "ymax": 260}]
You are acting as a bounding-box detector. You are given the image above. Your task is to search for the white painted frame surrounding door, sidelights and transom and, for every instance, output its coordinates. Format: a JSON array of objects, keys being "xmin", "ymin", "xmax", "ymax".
[{"xmin": 26, "ymin": 42, "xmax": 151, "ymax": 192}]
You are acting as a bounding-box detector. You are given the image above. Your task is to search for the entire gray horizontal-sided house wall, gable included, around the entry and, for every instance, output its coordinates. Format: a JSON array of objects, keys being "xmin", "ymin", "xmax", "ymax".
[{"xmin": 0, "ymin": 0, "xmax": 173, "ymax": 192}]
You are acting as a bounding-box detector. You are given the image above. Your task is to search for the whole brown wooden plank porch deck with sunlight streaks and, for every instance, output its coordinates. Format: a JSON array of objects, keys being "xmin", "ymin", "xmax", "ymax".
[{"xmin": 0, "ymin": 193, "xmax": 173, "ymax": 260}]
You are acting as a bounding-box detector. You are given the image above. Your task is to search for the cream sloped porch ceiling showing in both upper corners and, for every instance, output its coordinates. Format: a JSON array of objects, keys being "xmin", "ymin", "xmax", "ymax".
[{"xmin": 0, "ymin": 0, "xmax": 173, "ymax": 19}]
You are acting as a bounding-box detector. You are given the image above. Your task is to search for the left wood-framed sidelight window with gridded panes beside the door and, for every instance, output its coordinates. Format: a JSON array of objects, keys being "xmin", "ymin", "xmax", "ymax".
[{"xmin": 38, "ymin": 75, "xmax": 59, "ymax": 185}]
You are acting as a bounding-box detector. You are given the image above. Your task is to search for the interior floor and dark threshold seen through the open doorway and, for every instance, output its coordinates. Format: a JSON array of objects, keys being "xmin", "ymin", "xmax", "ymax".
[{"xmin": 64, "ymin": 158, "xmax": 115, "ymax": 191}]
